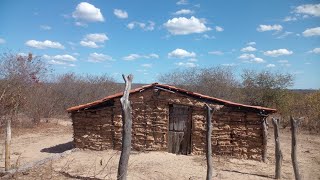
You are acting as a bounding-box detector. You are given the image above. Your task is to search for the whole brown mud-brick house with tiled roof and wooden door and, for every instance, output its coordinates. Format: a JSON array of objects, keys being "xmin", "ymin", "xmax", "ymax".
[{"xmin": 67, "ymin": 83, "xmax": 276, "ymax": 160}]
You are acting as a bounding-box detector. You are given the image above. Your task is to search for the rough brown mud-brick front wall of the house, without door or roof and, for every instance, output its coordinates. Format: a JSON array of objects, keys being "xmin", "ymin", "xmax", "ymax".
[{"xmin": 72, "ymin": 89, "xmax": 262, "ymax": 160}]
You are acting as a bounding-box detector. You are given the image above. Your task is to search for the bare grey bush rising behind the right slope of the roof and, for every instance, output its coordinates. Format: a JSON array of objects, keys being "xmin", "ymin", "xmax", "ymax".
[{"xmin": 159, "ymin": 67, "xmax": 240, "ymax": 101}]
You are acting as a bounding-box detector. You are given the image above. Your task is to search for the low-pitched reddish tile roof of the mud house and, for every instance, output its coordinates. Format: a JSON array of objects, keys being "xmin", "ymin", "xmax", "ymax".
[{"xmin": 67, "ymin": 83, "xmax": 277, "ymax": 113}]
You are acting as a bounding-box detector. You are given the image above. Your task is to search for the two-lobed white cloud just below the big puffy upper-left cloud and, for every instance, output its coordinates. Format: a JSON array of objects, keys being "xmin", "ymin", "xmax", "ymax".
[{"xmin": 80, "ymin": 33, "xmax": 109, "ymax": 48}]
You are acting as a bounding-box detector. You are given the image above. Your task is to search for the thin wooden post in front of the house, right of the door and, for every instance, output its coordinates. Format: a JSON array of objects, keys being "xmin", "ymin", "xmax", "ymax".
[{"xmin": 206, "ymin": 104, "xmax": 213, "ymax": 180}]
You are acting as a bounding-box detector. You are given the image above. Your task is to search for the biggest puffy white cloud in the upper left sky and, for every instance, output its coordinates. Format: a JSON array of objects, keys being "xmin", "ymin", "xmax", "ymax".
[{"xmin": 72, "ymin": 2, "xmax": 104, "ymax": 22}]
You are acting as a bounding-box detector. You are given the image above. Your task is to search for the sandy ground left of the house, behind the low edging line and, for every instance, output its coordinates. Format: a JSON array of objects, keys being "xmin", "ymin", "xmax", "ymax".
[{"xmin": 0, "ymin": 123, "xmax": 72, "ymax": 171}]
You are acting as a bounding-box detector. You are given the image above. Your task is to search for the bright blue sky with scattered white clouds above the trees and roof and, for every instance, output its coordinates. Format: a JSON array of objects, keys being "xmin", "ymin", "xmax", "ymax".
[{"xmin": 0, "ymin": 0, "xmax": 320, "ymax": 89}]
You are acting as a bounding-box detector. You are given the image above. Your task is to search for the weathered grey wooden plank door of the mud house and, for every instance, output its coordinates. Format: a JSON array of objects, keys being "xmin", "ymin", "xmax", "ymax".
[{"xmin": 168, "ymin": 105, "xmax": 192, "ymax": 154}]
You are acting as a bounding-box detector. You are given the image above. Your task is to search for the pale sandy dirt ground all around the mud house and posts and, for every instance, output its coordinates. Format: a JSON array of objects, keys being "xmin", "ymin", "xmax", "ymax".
[{"xmin": 0, "ymin": 121, "xmax": 320, "ymax": 180}]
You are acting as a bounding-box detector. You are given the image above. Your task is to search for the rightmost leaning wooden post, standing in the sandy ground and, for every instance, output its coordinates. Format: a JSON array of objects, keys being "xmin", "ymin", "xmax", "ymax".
[{"xmin": 290, "ymin": 116, "xmax": 301, "ymax": 180}]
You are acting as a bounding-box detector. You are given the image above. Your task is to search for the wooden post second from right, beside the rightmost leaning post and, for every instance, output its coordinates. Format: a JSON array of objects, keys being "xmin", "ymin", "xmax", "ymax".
[{"xmin": 272, "ymin": 118, "xmax": 282, "ymax": 179}]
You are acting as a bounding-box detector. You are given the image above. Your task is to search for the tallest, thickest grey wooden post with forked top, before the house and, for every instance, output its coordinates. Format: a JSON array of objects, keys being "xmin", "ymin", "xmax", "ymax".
[{"xmin": 117, "ymin": 74, "xmax": 133, "ymax": 180}]
